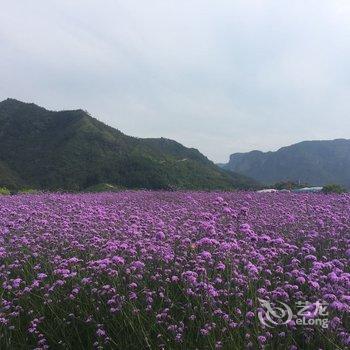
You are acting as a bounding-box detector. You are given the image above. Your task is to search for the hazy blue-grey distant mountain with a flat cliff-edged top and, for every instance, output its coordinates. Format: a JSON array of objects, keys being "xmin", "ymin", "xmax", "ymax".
[{"xmin": 221, "ymin": 139, "xmax": 350, "ymax": 188}]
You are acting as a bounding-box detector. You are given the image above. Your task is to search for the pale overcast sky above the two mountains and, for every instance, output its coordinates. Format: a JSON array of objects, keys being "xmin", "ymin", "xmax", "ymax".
[{"xmin": 0, "ymin": 0, "xmax": 350, "ymax": 162}]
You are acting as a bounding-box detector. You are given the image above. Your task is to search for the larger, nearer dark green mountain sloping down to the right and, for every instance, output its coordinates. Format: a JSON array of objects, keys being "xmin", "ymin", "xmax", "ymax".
[{"xmin": 0, "ymin": 99, "xmax": 256, "ymax": 191}]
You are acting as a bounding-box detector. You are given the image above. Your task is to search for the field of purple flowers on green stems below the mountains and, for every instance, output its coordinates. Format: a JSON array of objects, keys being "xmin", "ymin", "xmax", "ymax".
[{"xmin": 0, "ymin": 191, "xmax": 350, "ymax": 350}]
